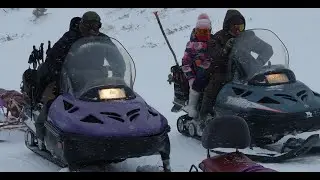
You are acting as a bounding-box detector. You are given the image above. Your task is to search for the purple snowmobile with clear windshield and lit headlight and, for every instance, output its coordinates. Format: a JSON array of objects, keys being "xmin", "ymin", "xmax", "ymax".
[{"xmin": 25, "ymin": 37, "xmax": 171, "ymax": 172}]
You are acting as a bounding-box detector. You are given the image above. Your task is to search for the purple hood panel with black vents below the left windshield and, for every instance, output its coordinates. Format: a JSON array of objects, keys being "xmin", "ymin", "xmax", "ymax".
[{"xmin": 48, "ymin": 94, "xmax": 168, "ymax": 137}]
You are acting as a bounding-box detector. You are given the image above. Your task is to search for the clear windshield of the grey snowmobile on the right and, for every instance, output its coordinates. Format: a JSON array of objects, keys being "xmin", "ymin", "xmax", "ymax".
[{"xmin": 230, "ymin": 29, "xmax": 289, "ymax": 80}]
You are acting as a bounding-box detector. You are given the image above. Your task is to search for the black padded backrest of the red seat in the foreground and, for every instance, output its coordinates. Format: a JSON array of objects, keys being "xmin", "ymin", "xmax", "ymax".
[{"xmin": 201, "ymin": 116, "xmax": 251, "ymax": 149}]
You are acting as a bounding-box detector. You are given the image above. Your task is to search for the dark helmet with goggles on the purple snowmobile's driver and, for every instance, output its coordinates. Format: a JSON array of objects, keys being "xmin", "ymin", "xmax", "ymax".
[{"xmin": 79, "ymin": 11, "xmax": 101, "ymax": 35}]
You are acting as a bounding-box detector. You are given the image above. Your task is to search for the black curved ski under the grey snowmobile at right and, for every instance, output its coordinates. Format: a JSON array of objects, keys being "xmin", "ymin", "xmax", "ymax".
[{"xmin": 210, "ymin": 134, "xmax": 320, "ymax": 163}]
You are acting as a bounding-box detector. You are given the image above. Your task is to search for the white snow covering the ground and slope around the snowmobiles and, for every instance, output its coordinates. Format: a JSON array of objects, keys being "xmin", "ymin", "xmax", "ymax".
[{"xmin": 0, "ymin": 8, "xmax": 320, "ymax": 171}]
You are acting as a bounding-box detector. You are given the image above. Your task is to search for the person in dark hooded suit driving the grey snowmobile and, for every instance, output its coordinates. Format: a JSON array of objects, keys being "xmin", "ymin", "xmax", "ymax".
[{"xmin": 199, "ymin": 9, "xmax": 272, "ymax": 123}]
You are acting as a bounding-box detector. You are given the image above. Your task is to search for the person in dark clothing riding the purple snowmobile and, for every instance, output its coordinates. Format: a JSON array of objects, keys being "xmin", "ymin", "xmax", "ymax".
[{"xmin": 35, "ymin": 11, "xmax": 126, "ymax": 149}]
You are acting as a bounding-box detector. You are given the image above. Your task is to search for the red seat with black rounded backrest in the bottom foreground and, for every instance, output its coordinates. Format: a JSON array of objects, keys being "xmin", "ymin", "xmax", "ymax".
[{"xmin": 189, "ymin": 116, "xmax": 277, "ymax": 172}]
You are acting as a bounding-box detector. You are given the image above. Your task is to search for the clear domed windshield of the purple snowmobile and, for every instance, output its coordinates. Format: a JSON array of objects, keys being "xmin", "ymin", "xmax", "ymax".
[{"xmin": 61, "ymin": 36, "xmax": 135, "ymax": 98}]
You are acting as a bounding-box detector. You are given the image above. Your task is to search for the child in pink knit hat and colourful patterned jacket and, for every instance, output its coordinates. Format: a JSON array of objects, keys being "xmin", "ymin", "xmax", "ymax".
[{"xmin": 182, "ymin": 13, "xmax": 212, "ymax": 118}]
